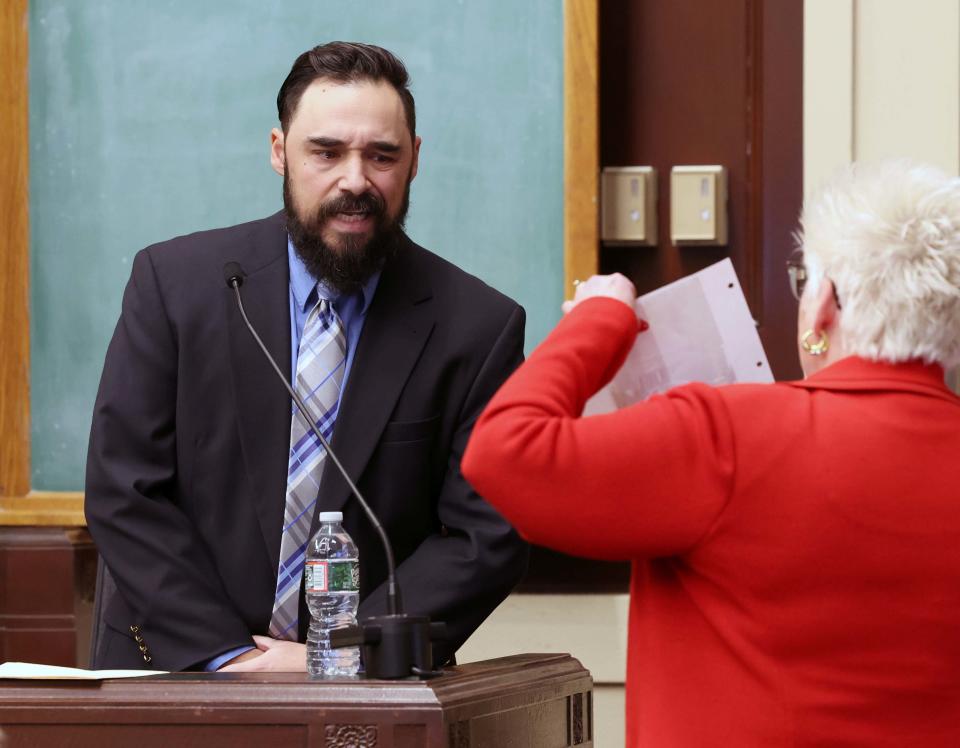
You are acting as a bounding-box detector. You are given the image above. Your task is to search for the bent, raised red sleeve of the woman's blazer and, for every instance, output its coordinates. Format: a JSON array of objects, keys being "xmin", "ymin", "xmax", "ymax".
[{"xmin": 462, "ymin": 299, "xmax": 734, "ymax": 560}]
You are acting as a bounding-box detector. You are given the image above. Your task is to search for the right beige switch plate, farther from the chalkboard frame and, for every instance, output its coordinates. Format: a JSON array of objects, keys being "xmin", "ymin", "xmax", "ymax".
[{"xmin": 670, "ymin": 166, "xmax": 727, "ymax": 246}]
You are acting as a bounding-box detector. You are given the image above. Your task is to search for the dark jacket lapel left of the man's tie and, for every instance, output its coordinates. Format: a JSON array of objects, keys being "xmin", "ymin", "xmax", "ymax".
[{"xmin": 224, "ymin": 219, "xmax": 291, "ymax": 568}]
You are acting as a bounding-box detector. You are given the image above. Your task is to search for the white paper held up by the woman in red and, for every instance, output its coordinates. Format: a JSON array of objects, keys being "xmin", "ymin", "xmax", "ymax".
[{"xmin": 583, "ymin": 259, "xmax": 773, "ymax": 415}]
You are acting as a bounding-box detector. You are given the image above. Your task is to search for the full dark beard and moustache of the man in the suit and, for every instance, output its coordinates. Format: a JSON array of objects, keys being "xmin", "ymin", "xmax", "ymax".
[{"xmin": 283, "ymin": 174, "xmax": 410, "ymax": 293}]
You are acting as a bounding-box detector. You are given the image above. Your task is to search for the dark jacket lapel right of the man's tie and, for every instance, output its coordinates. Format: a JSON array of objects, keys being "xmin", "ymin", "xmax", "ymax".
[{"xmin": 310, "ymin": 240, "xmax": 434, "ymax": 536}]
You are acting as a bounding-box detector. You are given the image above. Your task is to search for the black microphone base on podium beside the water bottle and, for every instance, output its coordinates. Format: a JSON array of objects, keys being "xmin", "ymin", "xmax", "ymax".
[{"xmin": 330, "ymin": 614, "xmax": 446, "ymax": 680}]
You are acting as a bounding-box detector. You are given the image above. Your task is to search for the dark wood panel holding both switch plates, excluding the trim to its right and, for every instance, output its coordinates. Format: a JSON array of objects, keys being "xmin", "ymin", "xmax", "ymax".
[{"xmin": 600, "ymin": 0, "xmax": 749, "ymax": 300}]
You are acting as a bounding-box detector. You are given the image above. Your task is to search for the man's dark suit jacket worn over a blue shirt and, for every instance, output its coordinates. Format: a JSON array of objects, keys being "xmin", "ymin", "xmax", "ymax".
[{"xmin": 86, "ymin": 214, "xmax": 527, "ymax": 670}]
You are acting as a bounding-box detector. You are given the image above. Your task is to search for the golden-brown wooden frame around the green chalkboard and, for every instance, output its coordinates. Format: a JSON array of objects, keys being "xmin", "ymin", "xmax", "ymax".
[{"xmin": 0, "ymin": 0, "xmax": 599, "ymax": 527}]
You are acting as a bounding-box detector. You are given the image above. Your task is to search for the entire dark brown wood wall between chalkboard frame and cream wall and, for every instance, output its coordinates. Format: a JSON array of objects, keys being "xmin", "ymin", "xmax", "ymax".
[{"xmin": 600, "ymin": 0, "xmax": 803, "ymax": 379}]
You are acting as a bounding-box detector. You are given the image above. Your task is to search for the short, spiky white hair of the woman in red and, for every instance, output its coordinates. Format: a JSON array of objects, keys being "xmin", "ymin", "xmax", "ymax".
[{"xmin": 797, "ymin": 160, "xmax": 960, "ymax": 367}]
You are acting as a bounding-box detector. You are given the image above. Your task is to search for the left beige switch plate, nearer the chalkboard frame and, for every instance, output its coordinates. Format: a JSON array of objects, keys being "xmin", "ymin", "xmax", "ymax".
[{"xmin": 600, "ymin": 166, "xmax": 657, "ymax": 246}]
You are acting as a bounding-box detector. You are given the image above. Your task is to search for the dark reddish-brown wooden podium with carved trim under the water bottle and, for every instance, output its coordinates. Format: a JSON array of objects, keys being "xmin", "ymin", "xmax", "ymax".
[{"xmin": 0, "ymin": 654, "xmax": 593, "ymax": 748}]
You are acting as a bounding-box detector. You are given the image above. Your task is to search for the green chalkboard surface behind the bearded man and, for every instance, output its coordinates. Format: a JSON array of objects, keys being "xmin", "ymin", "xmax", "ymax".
[{"xmin": 30, "ymin": 0, "xmax": 563, "ymax": 490}]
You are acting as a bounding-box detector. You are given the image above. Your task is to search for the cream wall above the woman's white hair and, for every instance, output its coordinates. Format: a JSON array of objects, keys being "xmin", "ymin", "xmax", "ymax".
[{"xmin": 803, "ymin": 0, "xmax": 960, "ymax": 391}]
